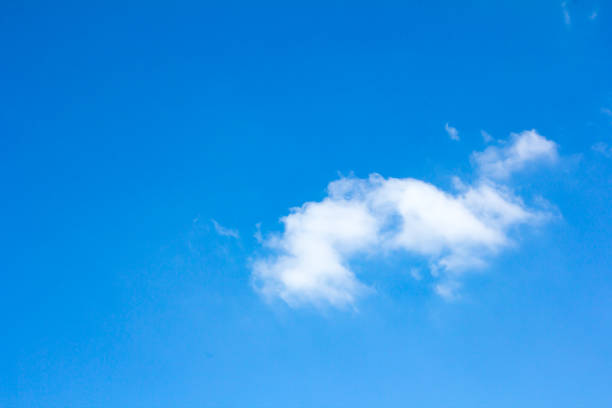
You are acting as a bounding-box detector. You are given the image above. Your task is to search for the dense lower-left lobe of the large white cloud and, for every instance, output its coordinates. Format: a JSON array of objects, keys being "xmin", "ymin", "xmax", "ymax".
[{"xmin": 253, "ymin": 197, "xmax": 378, "ymax": 306}]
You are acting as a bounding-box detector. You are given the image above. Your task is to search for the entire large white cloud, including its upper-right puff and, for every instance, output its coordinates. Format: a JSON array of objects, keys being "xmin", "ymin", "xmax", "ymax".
[{"xmin": 252, "ymin": 130, "xmax": 557, "ymax": 307}]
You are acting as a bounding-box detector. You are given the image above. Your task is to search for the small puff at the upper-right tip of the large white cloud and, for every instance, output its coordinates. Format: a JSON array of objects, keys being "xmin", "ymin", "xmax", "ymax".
[{"xmin": 472, "ymin": 130, "xmax": 558, "ymax": 179}]
